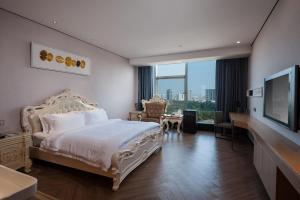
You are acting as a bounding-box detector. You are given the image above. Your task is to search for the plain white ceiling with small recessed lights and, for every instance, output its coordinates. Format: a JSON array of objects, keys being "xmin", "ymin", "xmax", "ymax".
[{"xmin": 0, "ymin": 0, "xmax": 276, "ymax": 58}]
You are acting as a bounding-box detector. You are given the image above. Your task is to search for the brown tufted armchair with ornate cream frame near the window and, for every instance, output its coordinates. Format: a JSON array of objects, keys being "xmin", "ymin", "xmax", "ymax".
[{"xmin": 140, "ymin": 96, "xmax": 167, "ymax": 123}]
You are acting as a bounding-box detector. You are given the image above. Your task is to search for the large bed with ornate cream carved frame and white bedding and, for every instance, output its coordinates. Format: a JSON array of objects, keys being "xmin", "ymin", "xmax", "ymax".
[{"xmin": 21, "ymin": 90, "xmax": 163, "ymax": 191}]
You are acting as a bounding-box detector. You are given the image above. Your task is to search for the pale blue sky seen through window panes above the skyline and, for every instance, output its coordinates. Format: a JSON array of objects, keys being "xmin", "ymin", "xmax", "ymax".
[{"xmin": 157, "ymin": 60, "xmax": 216, "ymax": 96}]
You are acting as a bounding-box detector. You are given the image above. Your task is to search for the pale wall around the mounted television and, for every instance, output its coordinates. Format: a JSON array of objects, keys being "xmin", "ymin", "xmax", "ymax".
[{"xmin": 248, "ymin": 0, "xmax": 300, "ymax": 145}]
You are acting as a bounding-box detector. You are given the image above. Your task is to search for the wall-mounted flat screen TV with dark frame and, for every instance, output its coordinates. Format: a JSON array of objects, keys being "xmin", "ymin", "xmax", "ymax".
[{"xmin": 263, "ymin": 65, "xmax": 299, "ymax": 131}]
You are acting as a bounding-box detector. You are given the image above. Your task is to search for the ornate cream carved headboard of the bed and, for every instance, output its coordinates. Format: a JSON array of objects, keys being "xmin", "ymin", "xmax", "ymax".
[{"xmin": 21, "ymin": 89, "xmax": 98, "ymax": 133}]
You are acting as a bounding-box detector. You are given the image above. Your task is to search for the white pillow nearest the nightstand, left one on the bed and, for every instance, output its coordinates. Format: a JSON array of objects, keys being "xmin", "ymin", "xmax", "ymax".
[{"xmin": 42, "ymin": 112, "xmax": 85, "ymax": 134}]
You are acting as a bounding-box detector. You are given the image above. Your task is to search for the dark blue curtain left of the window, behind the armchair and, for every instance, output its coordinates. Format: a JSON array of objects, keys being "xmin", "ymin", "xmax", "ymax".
[{"xmin": 137, "ymin": 66, "xmax": 153, "ymax": 110}]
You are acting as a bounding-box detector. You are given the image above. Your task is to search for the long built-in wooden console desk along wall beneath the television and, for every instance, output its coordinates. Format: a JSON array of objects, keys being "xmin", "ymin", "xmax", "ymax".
[{"xmin": 229, "ymin": 113, "xmax": 300, "ymax": 200}]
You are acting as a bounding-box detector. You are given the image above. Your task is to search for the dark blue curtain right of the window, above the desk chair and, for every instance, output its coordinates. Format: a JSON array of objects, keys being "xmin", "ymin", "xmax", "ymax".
[{"xmin": 216, "ymin": 58, "xmax": 248, "ymax": 121}]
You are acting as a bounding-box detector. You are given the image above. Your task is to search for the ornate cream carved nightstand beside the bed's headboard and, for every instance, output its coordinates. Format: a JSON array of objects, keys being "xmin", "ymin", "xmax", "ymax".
[{"xmin": 0, "ymin": 133, "xmax": 32, "ymax": 173}]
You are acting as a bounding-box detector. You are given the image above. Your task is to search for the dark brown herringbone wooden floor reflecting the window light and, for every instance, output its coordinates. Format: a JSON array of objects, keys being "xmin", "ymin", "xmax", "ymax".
[{"xmin": 30, "ymin": 132, "xmax": 268, "ymax": 200}]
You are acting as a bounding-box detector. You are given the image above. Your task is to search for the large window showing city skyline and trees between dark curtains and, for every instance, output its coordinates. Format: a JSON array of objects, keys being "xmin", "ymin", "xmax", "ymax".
[{"xmin": 154, "ymin": 60, "xmax": 216, "ymax": 123}]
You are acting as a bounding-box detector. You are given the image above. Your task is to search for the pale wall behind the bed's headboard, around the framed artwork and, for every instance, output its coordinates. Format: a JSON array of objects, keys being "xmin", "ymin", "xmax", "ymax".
[{"xmin": 0, "ymin": 9, "xmax": 135, "ymax": 131}]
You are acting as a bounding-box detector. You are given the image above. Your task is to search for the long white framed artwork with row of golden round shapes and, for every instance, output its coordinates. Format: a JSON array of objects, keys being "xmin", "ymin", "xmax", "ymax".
[{"xmin": 31, "ymin": 42, "xmax": 91, "ymax": 75}]
